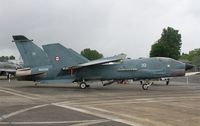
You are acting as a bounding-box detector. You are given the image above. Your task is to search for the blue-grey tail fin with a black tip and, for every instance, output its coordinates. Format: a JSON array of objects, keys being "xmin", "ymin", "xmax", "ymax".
[{"xmin": 13, "ymin": 35, "xmax": 50, "ymax": 67}]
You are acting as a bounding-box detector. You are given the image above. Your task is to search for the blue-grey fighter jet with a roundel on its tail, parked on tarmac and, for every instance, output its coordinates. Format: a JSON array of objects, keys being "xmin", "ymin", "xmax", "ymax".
[{"xmin": 13, "ymin": 35, "xmax": 193, "ymax": 90}]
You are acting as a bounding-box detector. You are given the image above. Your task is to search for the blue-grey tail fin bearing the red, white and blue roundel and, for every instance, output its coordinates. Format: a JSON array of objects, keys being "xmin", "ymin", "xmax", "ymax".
[{"xmin": 42, "ymin": 43, "xmax": 88, "ymax": 68}]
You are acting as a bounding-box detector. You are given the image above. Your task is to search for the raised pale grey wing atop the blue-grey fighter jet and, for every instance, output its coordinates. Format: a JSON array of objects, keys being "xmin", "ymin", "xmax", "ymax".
[{"xmin": 63, "ymin": 54, "xmax": 126, "ymax": 70}]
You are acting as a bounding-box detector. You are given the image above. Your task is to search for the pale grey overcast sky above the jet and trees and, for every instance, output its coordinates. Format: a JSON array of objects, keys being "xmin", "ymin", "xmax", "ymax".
[{"xmin": 0, "ymin": 0, "xmax": 200, "ymax": 58}]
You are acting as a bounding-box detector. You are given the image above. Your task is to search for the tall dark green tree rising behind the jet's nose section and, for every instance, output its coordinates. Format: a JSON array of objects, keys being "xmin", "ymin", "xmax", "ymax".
[{"xmin": 150, "ymin": 27, "xmax": 182, "ymax": 59}]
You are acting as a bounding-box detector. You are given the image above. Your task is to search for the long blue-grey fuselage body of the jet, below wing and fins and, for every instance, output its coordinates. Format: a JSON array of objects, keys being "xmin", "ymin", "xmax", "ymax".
[{"xmin": 17, "ymin": 57, "xmax": 185, "ymax": 83}]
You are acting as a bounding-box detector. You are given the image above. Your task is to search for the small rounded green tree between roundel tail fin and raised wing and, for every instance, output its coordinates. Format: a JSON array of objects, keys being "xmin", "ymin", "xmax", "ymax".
[{"xmin": 81, "ymin": 48, "xmax": 103, "ymax": 60}]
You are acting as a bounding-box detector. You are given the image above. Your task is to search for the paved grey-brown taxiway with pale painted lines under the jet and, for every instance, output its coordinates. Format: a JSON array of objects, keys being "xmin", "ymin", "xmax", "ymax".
[{"xmin": 0, "ymin": 77, "xmax": 200, "ymax": 126}]
